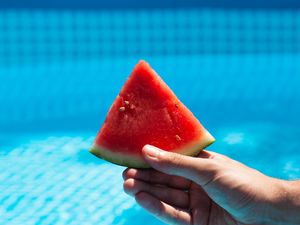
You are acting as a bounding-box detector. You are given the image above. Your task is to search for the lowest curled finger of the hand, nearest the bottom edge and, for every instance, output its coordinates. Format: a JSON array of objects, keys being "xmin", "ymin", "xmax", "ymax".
[{"xmin": 135, "ymin": 192, "xmax": 191, "ymax": 225}]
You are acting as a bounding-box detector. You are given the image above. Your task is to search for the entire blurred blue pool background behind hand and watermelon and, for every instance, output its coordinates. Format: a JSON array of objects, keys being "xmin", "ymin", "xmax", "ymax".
[{"xmin": 0, "ymin": 0, "xmax": 300, "ymax": 225}]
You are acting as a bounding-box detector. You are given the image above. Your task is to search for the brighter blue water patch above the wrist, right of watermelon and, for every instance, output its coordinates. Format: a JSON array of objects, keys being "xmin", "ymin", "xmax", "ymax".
[{"xmin": 210, "ymin": 122, "xmax": 300, "ymax": 179}]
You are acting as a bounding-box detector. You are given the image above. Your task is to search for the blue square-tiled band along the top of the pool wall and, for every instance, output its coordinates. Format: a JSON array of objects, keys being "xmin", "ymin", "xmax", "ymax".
[{"xmin": 0, "ymin": 9, "xmax": 300, "ymax": 65}]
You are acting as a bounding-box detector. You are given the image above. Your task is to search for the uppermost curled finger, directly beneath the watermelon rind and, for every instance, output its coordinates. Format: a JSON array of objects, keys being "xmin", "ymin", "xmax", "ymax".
[{"xmin": 123, "ymin": 168, "xmax": 191, "ymax": 190}]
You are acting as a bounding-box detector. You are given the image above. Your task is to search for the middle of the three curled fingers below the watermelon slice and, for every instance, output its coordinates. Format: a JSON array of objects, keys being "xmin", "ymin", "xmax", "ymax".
[{"xmin": 124, "ymin": 178, "xmax": 189, "ymax": 208}]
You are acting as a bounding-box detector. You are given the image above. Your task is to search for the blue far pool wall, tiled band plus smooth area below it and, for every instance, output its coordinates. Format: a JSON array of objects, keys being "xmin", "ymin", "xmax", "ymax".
[{"xmin": 0, "ymin": 9, "xmax": 300, "ymax": 130}]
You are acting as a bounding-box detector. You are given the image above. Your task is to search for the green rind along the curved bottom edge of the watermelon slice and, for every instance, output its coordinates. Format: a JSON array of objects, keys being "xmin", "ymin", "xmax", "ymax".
[{"xmin": 90, "ymin": 131, "xmax": 215, "ymax": 169}]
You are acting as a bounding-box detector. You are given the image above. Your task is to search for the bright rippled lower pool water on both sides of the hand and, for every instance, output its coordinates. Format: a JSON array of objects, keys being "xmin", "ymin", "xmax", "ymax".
[{"xmin": 0, "ymin": 123, "xmax": 300, "ymax": 224}]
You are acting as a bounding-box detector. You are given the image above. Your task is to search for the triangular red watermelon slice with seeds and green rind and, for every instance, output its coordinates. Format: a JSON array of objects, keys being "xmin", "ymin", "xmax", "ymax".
[{"xmin": 90, "ymin": 60, "xmax": 215, "ymax": 168}]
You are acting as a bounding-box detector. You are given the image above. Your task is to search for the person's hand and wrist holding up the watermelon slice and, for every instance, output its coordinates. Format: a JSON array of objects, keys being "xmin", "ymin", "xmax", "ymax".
[{"xmin": 123, "ymin": 145, "xmax": 300, "ymax": 225}]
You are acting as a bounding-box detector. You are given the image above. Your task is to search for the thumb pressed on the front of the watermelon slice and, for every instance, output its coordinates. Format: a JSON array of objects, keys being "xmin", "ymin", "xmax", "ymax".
[{"xmin": 142, "ymin": 145, "xmax": 220, "ymax": 186}]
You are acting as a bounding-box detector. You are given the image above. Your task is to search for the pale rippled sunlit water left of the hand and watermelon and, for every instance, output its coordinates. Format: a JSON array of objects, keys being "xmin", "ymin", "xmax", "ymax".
[{"xmin": 0, "ymin": 134, "xmax": 157, "ymax": 224}]
